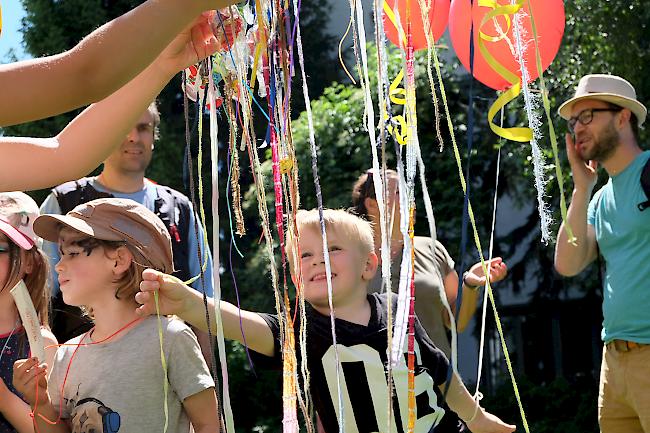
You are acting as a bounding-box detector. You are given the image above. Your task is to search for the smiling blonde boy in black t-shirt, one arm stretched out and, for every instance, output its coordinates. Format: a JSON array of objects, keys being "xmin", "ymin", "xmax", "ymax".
[{"xmin": 136, "ymin": 210, "xmax": 514, "ymax": 433}]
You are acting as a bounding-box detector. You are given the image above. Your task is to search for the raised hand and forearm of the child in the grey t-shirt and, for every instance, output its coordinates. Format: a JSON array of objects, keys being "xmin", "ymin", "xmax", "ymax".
[{"xmin": 13, "ymin": 358, "xmax": 70, "ymax": 433}]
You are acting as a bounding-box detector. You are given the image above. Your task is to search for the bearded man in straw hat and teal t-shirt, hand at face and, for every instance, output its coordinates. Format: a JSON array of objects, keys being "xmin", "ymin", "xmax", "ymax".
[{"xmin": 555, "ymin": 74, "xmax": 650, "ymax": 433}]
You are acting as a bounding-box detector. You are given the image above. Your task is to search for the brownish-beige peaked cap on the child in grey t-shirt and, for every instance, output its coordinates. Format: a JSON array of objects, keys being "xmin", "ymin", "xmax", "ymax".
[{"xmin": 34, "ymin": 198, "xmax": 174, "ymax": 274}]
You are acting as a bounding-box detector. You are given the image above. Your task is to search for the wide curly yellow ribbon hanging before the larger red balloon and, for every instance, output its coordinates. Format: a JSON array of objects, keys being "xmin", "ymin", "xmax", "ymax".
[{"xmin": 478, "ymin": 0, "xmax": 533, "ymax": 143}]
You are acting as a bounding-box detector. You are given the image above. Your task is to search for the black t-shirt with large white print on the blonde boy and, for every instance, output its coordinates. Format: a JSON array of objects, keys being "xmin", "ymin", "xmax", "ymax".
[{"xmin": 254, "ymin": 293, "xmax": 459, "ymax": 433}]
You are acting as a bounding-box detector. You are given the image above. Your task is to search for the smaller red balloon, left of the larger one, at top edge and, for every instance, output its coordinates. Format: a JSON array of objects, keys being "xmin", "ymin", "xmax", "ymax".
[{"xmin": 383, "ymin": 0, "xmax": 450, "ymax": 50}]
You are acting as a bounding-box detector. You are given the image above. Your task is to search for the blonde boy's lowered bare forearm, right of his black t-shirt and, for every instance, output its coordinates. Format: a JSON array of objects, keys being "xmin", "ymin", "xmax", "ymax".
[{"xmin": 439, "ymin": 374, "xmax": 515, "ymax": 433}]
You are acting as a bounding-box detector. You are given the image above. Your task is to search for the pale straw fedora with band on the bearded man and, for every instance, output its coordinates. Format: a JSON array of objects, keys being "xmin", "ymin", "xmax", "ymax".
[{"xmin": 558, "ymin": 74, "xmax": 648, "ymax": 126}]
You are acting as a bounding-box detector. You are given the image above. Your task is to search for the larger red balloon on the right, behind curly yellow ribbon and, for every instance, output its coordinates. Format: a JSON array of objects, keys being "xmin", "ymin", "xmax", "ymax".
[{"xmin": 449, "ymin": 0, "xmax": 564, "ymax": 90}]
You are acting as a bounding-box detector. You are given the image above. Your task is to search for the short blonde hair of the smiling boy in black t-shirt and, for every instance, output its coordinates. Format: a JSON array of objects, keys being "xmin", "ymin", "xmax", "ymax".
[{"xmin": 286, "ymin": 209, "xmax": 375, "ymax": 271}]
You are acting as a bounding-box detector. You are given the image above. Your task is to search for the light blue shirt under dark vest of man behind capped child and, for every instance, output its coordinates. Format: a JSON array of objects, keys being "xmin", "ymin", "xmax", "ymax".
[{"xmin": 41, "ymin": 178, "xmax": 214, "ymax": 297}]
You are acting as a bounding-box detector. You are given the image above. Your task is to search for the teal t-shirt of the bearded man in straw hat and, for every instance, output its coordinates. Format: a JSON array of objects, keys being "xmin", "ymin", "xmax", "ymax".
[{"xmin": 587, "ymin": 151, "xmax": 650, "ymax": 343}]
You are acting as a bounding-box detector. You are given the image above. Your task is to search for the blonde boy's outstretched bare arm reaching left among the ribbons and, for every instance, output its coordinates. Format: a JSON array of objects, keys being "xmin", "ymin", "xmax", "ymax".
[{"xmin": 135, "ymin": 269, "xmax": 275, "ymax": 356}]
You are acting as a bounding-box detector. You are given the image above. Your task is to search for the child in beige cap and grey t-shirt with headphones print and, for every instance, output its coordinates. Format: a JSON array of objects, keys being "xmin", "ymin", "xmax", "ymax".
[{"xmin": 14, "ymin": 198, "xmax": 219, "ymax": 432}]
